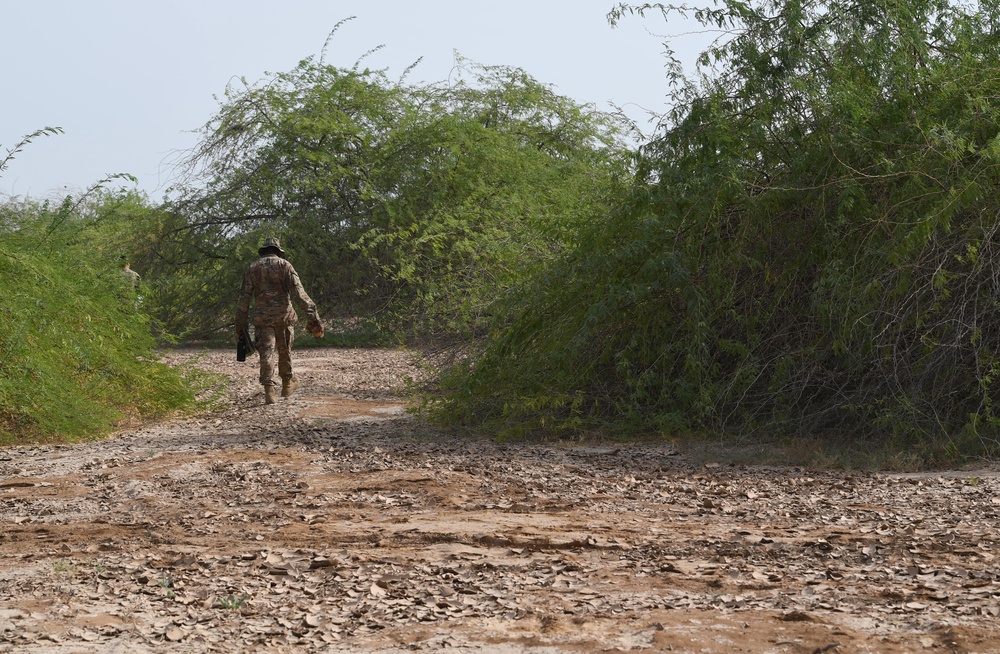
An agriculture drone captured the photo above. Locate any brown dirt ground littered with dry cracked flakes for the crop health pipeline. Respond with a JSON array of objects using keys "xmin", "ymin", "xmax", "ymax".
[{"xmin": 0, "ymin": 350, "xmax": 1000, "ymax": 654}]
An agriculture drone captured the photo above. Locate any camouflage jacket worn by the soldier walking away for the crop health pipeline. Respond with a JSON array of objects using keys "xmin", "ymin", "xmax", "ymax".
[{"xmin": 236, "ymin": 254, "xmax": 319, "ymax": 329}]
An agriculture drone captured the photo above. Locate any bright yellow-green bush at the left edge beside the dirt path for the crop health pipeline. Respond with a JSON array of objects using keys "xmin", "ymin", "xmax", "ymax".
[{"xmin": 0, "ymin": 194, "xmax": 204, "ymax": 442}]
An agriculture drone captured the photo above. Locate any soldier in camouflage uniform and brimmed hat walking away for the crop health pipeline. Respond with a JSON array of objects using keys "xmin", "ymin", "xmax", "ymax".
[{"xmin": 236, "ymin": 237, "xmax": 323, "ymax": 404}]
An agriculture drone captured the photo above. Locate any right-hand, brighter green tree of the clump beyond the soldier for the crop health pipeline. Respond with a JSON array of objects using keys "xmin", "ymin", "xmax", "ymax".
[{"xmin": 361, "ymin": 60, "xmax": 627, "ymax": 333}]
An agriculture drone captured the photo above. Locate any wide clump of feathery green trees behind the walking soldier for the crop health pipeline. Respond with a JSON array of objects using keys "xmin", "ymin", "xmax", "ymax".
[{"xmin": 151, "ymin": 28, "xmax": 627, "ymax": 335}]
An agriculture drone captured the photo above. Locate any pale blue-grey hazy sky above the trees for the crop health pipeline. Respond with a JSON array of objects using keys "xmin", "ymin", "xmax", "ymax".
[{"xmin": 0, "ymin": 0, "xmax": 697, "ymax": 201}]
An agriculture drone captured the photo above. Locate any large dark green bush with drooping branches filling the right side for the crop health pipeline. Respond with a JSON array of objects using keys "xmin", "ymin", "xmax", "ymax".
[{"xmin": 434, "ymin": 0, "xmax": 1000, "ymax": 451}]
